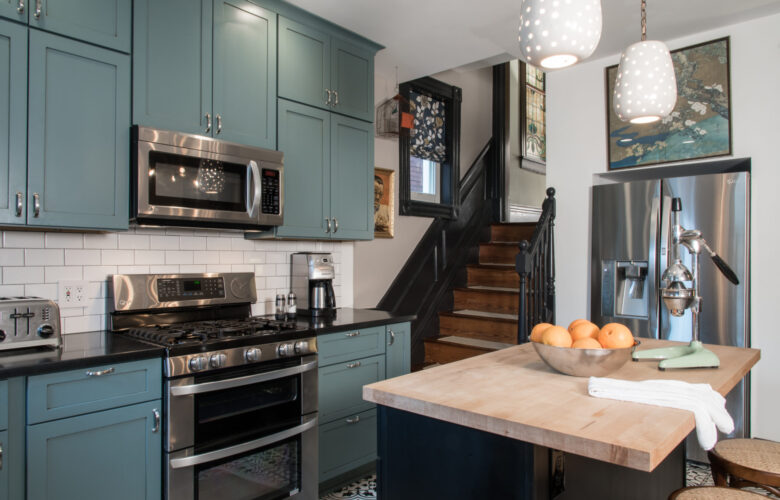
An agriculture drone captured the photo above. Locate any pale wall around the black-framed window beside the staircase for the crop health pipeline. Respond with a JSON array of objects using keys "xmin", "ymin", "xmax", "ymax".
[{"xmin": 354, "ymin": 67, "xmax": 493, "ymax": 307}]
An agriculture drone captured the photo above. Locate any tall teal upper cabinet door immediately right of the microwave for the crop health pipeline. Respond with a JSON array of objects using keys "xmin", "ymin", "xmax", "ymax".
[{"xmin": 277, "ymin": 99, "xmax": 330, "ymax": 238}]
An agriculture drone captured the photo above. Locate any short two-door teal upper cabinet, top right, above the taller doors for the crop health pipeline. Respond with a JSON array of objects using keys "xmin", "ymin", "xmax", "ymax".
[{"xmin": 279, "ymin": 16, "xmax": 375, "ymax": 122}]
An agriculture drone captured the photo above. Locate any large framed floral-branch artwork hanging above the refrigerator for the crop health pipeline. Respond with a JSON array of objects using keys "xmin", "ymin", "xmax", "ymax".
[{"xmin": 605, "ymin": 37, "xmax": 731, "ymax": 170}]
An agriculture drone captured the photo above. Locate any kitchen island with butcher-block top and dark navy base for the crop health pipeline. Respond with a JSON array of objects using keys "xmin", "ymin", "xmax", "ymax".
[{"xmin": 363, "ymin": 339, "xmax": 760, "ymax": 500}]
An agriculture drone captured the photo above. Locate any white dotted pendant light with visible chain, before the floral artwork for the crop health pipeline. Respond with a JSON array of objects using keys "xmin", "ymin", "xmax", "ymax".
[{"xmin": 612, "ymin": 0, "xmax": 677, "ymax": 123}]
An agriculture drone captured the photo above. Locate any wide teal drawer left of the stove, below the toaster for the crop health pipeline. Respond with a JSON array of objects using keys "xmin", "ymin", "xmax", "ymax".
[{"xmin": 27, "ymin": 359, "xmax": 162, "ymax": 424}]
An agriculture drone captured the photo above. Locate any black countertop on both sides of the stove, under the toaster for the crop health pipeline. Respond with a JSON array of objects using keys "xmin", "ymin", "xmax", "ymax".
[{"xmin": 0, "ymin": 308, "xmax": 415, "ymax": 379}]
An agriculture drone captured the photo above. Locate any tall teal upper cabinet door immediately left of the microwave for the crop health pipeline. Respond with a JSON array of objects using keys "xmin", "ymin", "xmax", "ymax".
[{"xmin": 27, "ymin": 30, "xmax": 130, "ymax": 229}]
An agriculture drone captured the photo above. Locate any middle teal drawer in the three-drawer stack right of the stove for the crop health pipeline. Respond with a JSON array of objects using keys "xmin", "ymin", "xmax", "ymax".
[{"xmin": 319, "ymin": 356, "xmax": 385, "ymax": 422}]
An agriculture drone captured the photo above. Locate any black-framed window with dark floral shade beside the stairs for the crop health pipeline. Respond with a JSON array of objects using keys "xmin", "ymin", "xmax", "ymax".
[{"xmin": 398, "ymin": 77, "xmax": 462, "ymax": 218}]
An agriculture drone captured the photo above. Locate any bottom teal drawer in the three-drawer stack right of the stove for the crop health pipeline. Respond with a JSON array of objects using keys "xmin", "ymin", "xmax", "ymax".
[{"xmin": 320, "ymin": 408, "xmax": 377, "ymax": 482}]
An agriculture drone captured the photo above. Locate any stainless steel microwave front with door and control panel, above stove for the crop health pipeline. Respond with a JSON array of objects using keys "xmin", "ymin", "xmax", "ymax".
[{"xmin": 135, "ymin": 141, "xmax": 282, "ymax": 227}]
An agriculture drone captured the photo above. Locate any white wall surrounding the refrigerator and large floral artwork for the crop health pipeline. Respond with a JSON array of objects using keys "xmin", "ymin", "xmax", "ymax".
[{"xmin": 547, "ymin": 15, "xmax": 780, "ymax": 440}]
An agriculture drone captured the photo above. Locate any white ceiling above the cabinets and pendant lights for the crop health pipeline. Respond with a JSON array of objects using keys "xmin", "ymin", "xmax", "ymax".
[{"xmin": 288, "ymin": 0, "xmax": 780, "ymax": 81}]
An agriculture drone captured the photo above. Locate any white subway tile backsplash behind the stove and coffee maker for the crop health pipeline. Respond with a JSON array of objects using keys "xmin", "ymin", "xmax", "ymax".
[{"xmin": 0, "ymin": 228, "xmax": 352, "ymax": 334}]
